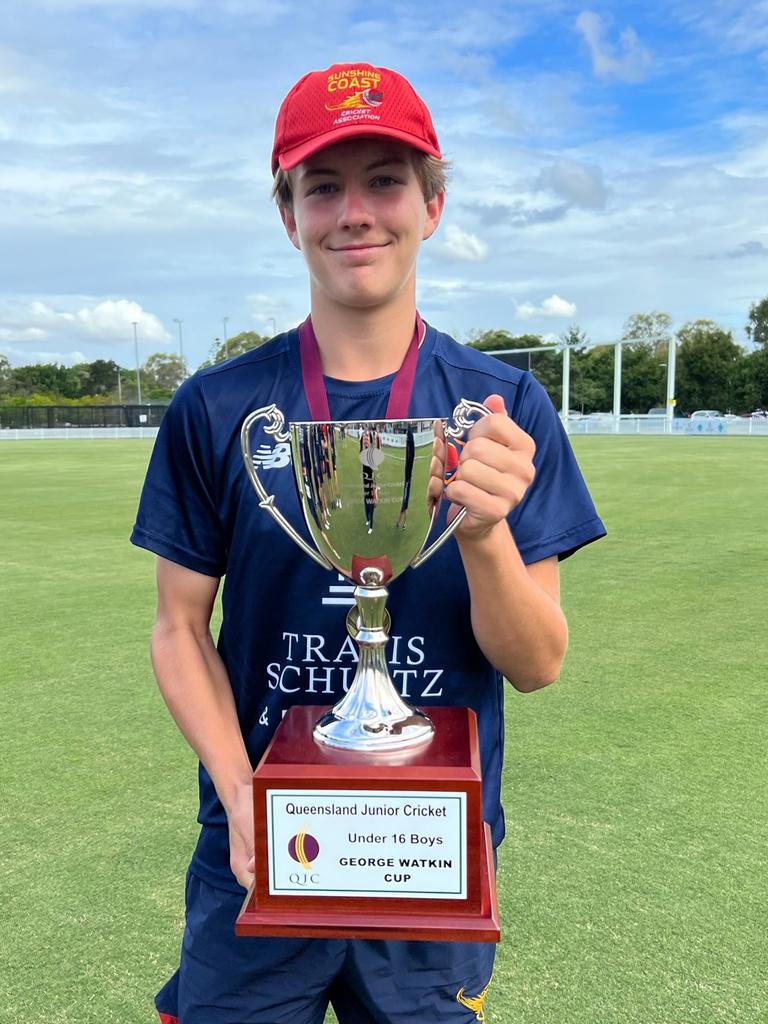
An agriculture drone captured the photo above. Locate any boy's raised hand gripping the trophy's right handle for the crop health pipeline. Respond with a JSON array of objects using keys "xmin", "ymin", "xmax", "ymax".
[{"xmin": 429, "ymin": 394, "xmax": 536, "ymax": 540}]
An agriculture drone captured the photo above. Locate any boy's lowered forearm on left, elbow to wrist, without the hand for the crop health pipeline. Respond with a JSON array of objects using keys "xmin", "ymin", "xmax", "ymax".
[{"xmin": 152, "ymin": 624, "xmax": 253, "ymax": 809}]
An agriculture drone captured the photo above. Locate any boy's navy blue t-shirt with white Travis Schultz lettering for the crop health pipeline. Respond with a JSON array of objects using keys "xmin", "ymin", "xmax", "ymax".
[{"xmin": 131, "ymin": 327, "xmax": 605, "ymax": 890}]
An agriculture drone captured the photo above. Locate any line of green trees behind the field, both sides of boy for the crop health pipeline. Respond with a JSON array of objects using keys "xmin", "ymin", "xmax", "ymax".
[{"xmin": 0, "ymin": 296, "xmax": 768, "ymax": 414}]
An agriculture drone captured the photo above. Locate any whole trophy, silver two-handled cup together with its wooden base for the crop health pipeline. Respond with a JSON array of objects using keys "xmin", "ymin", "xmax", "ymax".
[{"xmin": 236, "ymin": 400, "xmax": 500, "ymax": 942}]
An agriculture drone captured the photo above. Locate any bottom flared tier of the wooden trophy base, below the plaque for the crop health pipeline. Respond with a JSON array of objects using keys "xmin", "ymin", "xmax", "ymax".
[{"xmin": 234, "ymin": 824, "xmax": 501, "ymax": 942}]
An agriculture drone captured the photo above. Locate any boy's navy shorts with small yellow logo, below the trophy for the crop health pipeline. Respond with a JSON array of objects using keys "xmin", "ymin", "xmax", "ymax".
[{"xmin": 156, "ymin": 872, "xmax": 496, "ymax": 1024}]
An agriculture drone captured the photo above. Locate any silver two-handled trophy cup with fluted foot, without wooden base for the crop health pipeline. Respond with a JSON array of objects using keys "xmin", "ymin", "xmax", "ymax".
[{"xmin": 241, "ymin": 399, "xmax": 489, "ymax": 752}]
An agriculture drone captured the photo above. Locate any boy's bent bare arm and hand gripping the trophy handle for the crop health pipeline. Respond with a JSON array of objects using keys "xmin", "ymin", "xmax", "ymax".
[{"xmin": 436, "ymin": 395, "xmax": 568, "ymax": 690}]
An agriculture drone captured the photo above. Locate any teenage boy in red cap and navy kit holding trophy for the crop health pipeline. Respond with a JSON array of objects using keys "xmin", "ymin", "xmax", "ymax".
[{"xmin": 132, "ymin": 63, "xmax": 604, "ymax": 1024}]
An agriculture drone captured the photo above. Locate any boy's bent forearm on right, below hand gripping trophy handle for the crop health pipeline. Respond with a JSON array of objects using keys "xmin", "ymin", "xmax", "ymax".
[{"xmin": 457, "ymin": 521, "xmax": 568, "ymax": 691}]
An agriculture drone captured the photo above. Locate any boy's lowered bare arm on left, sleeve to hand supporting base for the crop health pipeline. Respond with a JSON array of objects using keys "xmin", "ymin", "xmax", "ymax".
[{"xmin": 152, "ymin": 558, "xmax": 254, "ymax": 888}]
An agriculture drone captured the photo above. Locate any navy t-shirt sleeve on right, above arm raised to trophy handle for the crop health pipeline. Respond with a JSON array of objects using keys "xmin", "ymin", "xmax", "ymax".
[{"xmin": 509, "ymin": 375, "xmax": 605, "ymax": 565}]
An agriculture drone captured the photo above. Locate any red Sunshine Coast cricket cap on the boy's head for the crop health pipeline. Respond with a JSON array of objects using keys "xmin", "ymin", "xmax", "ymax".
[{"xmin": 272, "ymin": 63, "xmax": 442, "ymax": 174}]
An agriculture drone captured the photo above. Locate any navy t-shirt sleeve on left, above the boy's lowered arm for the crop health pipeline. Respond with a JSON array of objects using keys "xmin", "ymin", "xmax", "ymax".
[{"xmin": 131, "ymin": 377, "xmax": 226, "ymax": 577}]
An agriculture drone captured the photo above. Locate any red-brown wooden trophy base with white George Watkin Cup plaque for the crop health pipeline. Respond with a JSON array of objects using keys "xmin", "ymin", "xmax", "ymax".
[{"xmin": 236, "ymin": 707, "xmax": 501, "ymax": 942}]
